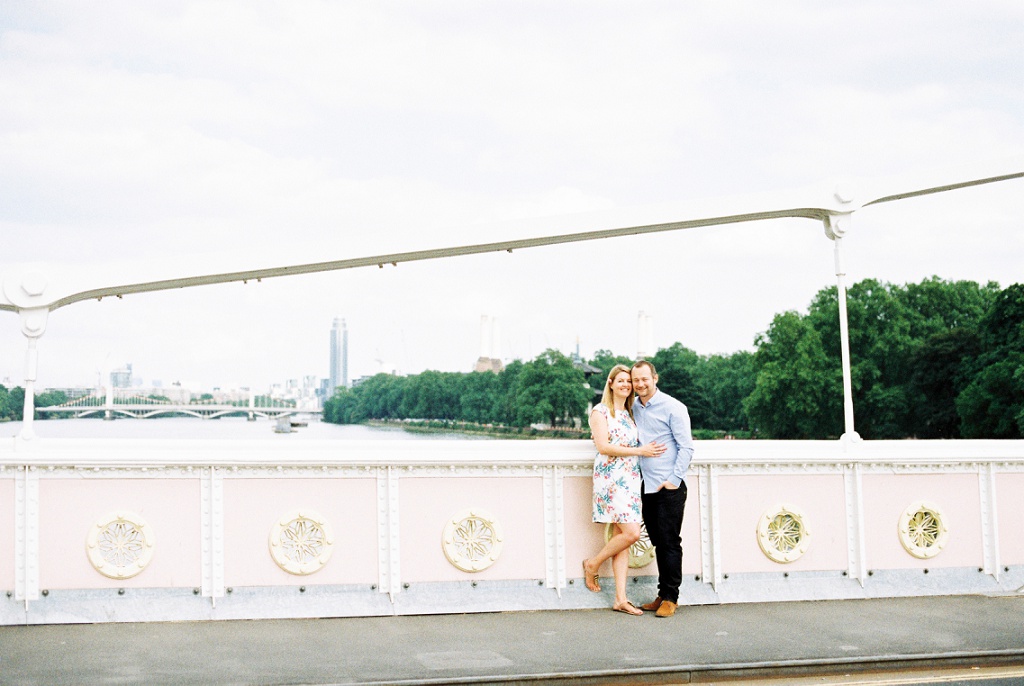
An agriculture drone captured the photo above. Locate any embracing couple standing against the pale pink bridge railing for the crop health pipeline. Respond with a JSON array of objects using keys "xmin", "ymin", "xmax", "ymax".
[{"xmin": 583, "ymin": 359, "xmax": 693, "ymax": 617}]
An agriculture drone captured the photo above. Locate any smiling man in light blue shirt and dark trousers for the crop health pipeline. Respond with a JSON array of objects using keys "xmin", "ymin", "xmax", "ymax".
[{"xmin": 630, "ymin": 359, "xmax": 693, "ymax": 617}]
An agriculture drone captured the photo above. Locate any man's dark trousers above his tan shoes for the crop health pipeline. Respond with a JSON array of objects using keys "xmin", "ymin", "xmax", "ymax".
[{"xmin": 641, "ymin": 483, "xmax": 686, "ymax": 604}]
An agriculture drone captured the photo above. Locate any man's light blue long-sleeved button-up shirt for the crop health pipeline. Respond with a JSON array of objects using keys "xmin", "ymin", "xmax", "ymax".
[{"xmin": 633, "ymin": 391, "xmax": 693, "ymax": 494}]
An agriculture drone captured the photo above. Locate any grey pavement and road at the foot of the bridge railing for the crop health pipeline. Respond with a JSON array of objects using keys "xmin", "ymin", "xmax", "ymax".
[{"xmin": 0, "ymin": 595, "xmax": 1024, "ymax": 686}]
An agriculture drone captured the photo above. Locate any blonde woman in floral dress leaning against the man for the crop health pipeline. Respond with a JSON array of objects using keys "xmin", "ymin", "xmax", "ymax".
[{"xmin": 583, "ymin": 365, "xmax": 665, "ymax": 615}]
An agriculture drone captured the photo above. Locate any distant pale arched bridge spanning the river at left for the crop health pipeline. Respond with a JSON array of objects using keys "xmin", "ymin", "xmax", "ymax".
[{"xmin": 36, "ymin": 388, "xmax": 323, "ymax": 419}]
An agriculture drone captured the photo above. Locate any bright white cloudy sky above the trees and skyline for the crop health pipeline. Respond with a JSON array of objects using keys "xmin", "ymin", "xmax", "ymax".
[{"xmin": 0, "ymin": 0, "xmax": 1024, "ymax": 389}]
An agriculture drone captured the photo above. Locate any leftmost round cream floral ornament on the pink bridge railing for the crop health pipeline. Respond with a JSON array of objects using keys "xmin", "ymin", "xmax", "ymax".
[{"xmin": 85, "ymin": 511, "xmax": 157, "ymax": 578}]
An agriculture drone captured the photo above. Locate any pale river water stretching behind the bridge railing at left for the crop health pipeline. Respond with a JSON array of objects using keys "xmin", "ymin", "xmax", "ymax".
[{"xmin": 0, "ymin": 417, "xmax": 479, "ymax": 441}]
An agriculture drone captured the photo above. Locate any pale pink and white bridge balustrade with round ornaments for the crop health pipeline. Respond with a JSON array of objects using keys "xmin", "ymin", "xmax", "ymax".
[{"xmin": 0, "ymin": 439, "xmax": 1024, "ymax": 625}]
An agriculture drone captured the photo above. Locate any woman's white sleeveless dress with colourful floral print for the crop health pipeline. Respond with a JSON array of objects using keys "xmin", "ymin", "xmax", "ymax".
[{"xmin": 591, "ymin": 404, "xmax": 643, "ymax": 523}]
